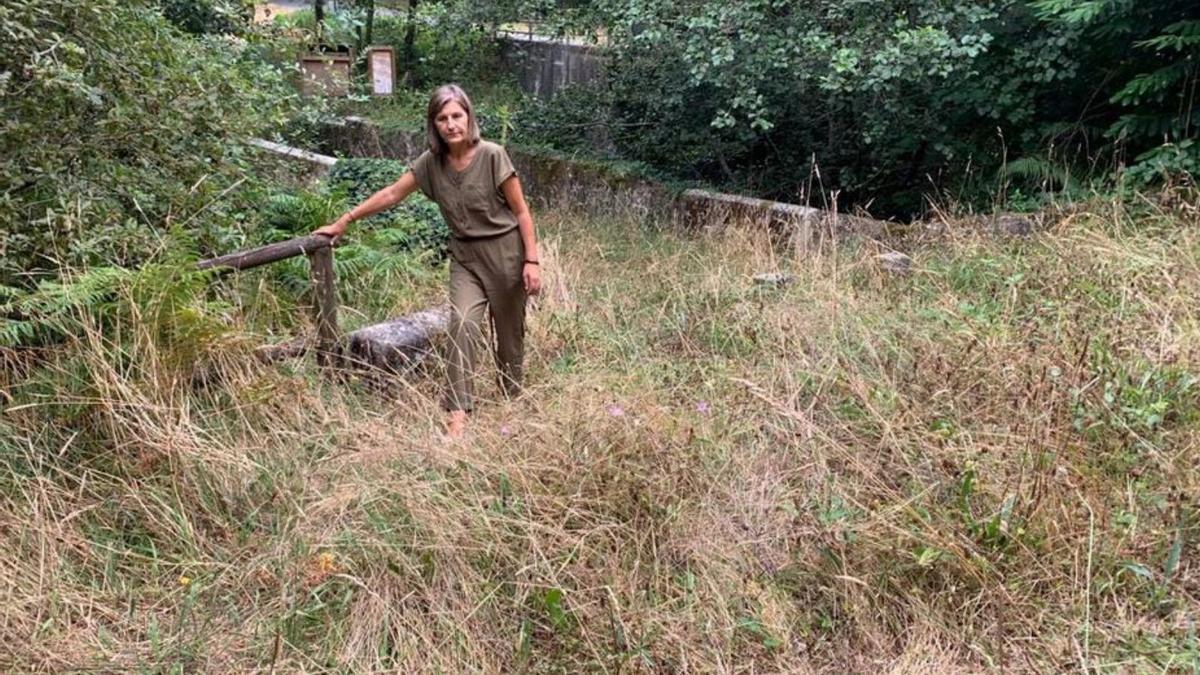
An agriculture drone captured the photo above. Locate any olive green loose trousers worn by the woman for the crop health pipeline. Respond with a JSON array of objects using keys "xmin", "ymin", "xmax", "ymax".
[{"xmin": 443, "ymin": 229, "xmax": 526, "ymax": 412}]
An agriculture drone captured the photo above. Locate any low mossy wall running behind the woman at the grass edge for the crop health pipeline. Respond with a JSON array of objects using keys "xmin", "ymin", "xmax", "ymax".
[{"xmin": 323, "ymin": 118, "xmax": 886, "ymax": 245}]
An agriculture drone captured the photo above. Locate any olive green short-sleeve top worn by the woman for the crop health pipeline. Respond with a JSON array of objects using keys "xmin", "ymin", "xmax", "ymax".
[{"xmin": 409, "ymin": 141, "xmax": 517, "ymax": 239}]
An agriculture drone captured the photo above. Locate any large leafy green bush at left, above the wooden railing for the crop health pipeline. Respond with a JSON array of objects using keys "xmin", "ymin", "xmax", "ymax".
[{"xmin": 0, "ymin": 0, "xmax": 301, "ymax": 286}]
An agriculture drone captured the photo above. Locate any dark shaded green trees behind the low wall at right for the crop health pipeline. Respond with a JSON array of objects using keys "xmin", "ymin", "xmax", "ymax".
[{"xmin": 462, "ymin": 0, "xmax": 1200, "ymax": 216}]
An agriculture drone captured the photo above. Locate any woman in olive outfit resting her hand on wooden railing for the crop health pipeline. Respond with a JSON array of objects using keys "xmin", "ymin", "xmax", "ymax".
[{"xmin": 314, "ymin": 84, "xmax": 541, "ymax": 437}]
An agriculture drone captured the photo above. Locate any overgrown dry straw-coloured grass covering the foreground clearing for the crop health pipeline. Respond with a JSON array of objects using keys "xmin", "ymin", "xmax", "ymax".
[{"xmin": 0, "ymin": 196, "xmax": 1200, "ymax": 673}]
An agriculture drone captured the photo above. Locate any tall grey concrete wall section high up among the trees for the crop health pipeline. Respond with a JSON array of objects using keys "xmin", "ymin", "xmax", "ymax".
[{"xmin": 497, "ymin": 32, "xmax": 605, "ymax": 98}]
